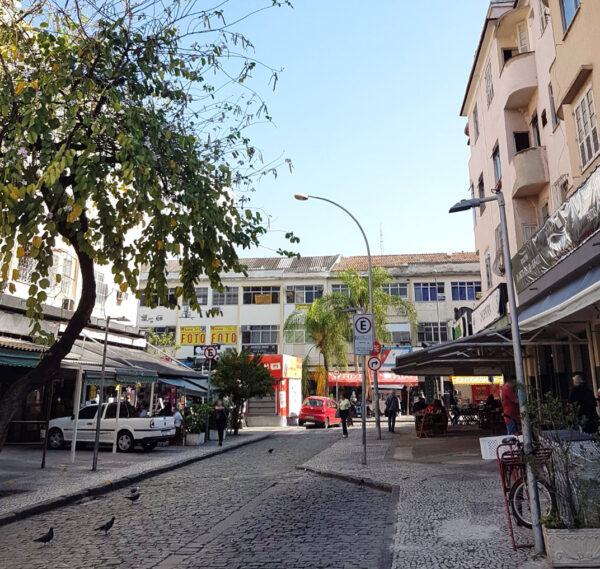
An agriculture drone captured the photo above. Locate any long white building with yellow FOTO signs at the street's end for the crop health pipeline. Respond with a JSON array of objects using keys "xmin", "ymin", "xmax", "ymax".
[{"xmin": 137, "ymin": 253, "xmax": 481, "ymax": 363}]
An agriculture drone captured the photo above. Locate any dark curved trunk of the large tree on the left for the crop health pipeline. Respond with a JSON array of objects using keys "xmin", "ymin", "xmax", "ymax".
[{"xmin": 0, "ymin": 243, "xmax": 96, "ymax": 451}]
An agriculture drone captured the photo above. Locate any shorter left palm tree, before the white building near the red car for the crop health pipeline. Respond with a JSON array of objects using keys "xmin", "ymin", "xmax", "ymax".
[{"xmin": 284, "ymin": 293, "xmax": 350, "ymax": 395}]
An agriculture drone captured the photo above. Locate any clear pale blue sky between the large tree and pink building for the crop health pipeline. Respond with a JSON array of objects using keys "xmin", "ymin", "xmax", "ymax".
[{"xmin": 232, "ymin": 0, "xmax": 489, "ymax": 257}]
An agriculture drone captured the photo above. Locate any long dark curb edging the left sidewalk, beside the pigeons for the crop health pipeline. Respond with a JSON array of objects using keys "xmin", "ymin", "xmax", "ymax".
[{"xmin": 0, "ymin": 433, "xmax": 271, "ymax": 527}]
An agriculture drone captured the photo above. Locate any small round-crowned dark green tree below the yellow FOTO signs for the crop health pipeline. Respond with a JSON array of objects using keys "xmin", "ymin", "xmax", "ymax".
[{"xmin": 211, "ymin": 350, "xmax": 273, "ymax": 435}]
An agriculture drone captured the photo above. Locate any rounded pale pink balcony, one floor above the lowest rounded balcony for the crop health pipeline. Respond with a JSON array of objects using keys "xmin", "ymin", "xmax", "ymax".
[{"xmin": 500, "ymin": 51, "xmax": 538, "ymax": 110}]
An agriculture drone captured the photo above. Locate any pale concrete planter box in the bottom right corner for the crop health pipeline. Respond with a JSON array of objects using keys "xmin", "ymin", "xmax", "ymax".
[{"xmin": 543, "ymin": 528, "xmax": 600, "ymax": 567}]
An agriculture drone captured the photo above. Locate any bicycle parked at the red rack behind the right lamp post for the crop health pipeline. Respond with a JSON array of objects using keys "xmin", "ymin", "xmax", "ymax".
[{"xmin": 496, "ymin": 437, "xmax": 555, "ymax": 549}]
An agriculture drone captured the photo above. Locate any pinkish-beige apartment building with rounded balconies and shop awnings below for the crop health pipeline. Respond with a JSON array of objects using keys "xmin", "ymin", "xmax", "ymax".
[{"xmin": 460, "ymin": 0, "xmax": 600, "ymax": 397}]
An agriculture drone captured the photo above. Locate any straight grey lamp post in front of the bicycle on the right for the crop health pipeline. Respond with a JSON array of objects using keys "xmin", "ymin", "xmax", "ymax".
[{"xmin": 450, "ymin": 189, "xmax": 544, "ymax": 553}]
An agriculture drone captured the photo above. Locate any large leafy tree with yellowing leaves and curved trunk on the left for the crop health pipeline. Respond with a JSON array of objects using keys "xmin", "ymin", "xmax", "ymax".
[{"xmin": 0, "ymin": 0, "xmax": 295, "ymax": 448}]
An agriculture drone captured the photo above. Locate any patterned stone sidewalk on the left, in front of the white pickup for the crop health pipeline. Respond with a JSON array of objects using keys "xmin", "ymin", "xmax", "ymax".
[{"xmin": 0, "ymin": 429, "xmax": 271, "ymax": 526}]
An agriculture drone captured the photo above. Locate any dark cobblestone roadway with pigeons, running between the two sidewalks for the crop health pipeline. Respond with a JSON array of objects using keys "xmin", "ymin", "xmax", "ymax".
[{"xmin": 0, "ymin": 429, "xmax": 391, "ymax": 569}]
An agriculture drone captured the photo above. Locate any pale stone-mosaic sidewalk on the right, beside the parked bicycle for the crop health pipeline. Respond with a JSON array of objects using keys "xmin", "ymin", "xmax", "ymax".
[{"xmin": 300, "ymin": 420, "xmax": 549, "ymax": 569}]
